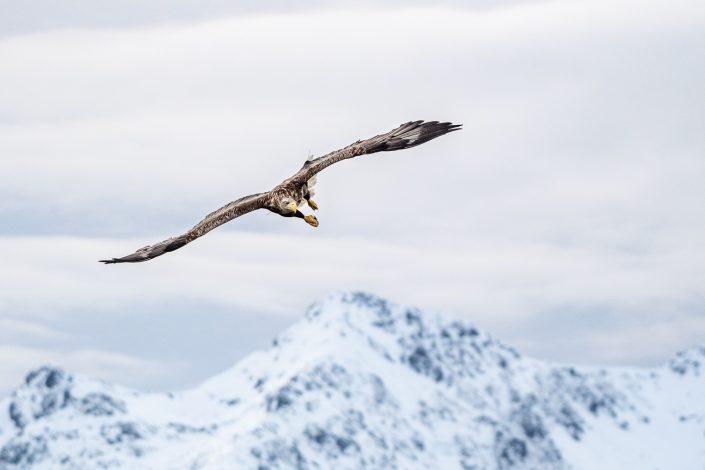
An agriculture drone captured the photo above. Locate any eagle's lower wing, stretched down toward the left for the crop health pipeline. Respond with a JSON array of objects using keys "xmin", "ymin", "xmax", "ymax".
[{"xmin": 100, "ymin": 193, "xmax": 269, "ymax": 264}]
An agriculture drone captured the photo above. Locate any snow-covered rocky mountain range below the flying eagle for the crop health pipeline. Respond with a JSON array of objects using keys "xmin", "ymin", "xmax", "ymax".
[{"xmin": 0, "ymin": 293, "xmax": 705, "ymax": 470}]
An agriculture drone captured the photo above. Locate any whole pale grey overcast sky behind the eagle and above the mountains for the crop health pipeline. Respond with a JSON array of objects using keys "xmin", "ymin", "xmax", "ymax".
[{"xmin": 0, "ymin": 0, "xmax": 705, "ymax": 391}]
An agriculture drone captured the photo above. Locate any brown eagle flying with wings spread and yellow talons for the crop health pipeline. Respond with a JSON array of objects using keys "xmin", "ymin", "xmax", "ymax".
[{"xmin": 100, "ymin": 121, "xmax": 462, "ymax": 264}]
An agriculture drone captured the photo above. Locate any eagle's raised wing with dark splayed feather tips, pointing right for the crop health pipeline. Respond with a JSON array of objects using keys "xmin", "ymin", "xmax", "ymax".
[{"xmin": 288, "ymin": 121, "xmax": 462, "ymax": 184}]
